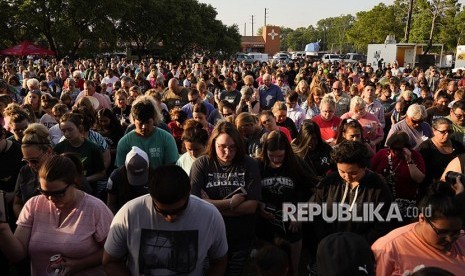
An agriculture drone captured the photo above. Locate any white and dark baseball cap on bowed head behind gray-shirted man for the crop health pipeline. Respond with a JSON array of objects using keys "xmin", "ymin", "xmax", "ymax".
[{"xmin": 124, "ymin": 146, "xmax": 149, "ymax": 186}]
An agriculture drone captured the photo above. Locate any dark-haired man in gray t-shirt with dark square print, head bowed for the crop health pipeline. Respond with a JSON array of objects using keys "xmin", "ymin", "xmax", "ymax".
[{"xmin": 103, "ymin": 165, "xmax": 228, "ymax": 275}]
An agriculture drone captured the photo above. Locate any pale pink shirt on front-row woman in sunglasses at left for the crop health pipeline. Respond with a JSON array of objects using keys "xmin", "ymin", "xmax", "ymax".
[{"xmin": 17, "ymin": 194, "xmax": 113, "ymax": 275}]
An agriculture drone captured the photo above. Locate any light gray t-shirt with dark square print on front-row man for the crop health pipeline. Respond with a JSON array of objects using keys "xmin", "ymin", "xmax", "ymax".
[{"xmin": 105, "ymin": 195, "xmax": 228, "ymax": 275}]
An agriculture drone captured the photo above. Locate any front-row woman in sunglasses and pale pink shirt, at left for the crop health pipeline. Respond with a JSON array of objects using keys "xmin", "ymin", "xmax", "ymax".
[{"xmin": 0, "ymin": 156, "xmax": 113, "ymax": 275}]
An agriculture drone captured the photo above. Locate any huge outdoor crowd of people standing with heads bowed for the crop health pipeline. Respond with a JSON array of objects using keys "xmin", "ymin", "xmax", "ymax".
[{"xmin": 0, "ymin": 57, "xmax": 465, "ymax": 275}]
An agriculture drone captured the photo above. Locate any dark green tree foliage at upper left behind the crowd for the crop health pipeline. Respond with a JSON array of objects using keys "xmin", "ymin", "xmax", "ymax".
[{"xmin": 0, "ymin": 0, "xmax": 240, "ymax": 58}]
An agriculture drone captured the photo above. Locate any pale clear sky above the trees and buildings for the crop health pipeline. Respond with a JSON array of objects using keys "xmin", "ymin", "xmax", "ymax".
[{"xmin": 199, "ymin": 0, "xmax": 465, "ymax": 35}]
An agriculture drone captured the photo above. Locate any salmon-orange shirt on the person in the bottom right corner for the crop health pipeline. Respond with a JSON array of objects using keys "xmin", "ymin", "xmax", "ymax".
[{"xmin": 371, "ymin": 223, "xmax": 465, "ymax": 276}]
